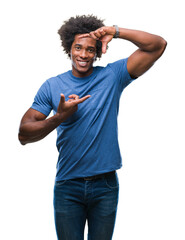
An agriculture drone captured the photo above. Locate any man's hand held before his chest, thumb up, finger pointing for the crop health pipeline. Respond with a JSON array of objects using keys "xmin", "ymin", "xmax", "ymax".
[{"xmin": 56, "ymin": 94, "xmax": 90, "ymax": 122}]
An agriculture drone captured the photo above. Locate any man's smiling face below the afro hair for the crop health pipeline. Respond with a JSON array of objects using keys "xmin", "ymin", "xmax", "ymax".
[{"xmin": 71, "ymin": 34, "xmax": 96, "ymax": 77}]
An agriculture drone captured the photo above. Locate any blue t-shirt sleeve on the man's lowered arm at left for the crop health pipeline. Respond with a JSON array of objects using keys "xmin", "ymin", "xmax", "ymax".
[{"xmin": 31, "ymin": 81, "xmax": 53, "ymax": 116}]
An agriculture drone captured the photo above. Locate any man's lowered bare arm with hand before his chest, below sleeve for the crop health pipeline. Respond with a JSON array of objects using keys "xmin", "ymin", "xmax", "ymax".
[{"xmin": 18, "ymin": 94, "xmax": 90, "ymax": 145}]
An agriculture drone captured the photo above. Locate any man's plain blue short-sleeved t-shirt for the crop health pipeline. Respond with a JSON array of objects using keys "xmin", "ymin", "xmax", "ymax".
[{"xmin": 31, "ymin": 59, "xmax": 136, "ymax": 181}]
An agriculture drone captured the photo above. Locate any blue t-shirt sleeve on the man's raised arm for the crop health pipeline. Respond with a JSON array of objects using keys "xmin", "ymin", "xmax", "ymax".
[{"xmin": 109, "ymin": 58, "xmax": 136, "ymax": 90}]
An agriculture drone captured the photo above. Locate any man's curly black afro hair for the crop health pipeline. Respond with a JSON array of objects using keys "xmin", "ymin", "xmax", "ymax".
[{"xmin": 58, "ymin": 15, "xmax": 105, "ymax": 58}]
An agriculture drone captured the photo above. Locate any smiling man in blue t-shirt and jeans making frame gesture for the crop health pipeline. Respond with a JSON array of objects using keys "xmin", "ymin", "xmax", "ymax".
[{"xmin": 19, "ymin": 16, "xmax": 167, "ymax": 240}]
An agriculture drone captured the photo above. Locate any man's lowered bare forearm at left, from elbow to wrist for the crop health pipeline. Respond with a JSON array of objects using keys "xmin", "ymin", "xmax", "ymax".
[{"xmin": 19, "ymin": 114, "xmax": 62, "ymax": 145}]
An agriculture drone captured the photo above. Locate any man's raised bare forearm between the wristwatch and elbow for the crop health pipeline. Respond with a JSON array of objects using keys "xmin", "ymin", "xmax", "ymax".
[{"xmin": 119, "ymin": 28, "xmax": 165, "ymax": 52}]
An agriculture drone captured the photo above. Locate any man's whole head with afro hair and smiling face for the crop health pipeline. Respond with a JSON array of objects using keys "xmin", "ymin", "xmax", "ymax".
[{"xmin": 58, "ymin": 15, "xmax": 104, "ymax": 75}]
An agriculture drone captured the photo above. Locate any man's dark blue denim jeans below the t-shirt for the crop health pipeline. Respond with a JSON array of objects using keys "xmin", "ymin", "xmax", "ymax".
[{"xmin": 54, "ymin": 172, "xmax": 119, "ymax": 240}]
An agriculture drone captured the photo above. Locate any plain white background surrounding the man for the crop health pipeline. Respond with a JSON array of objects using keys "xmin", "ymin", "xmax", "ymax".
[{"xmin": 0, "ymin": 0, "xmax": 185, "ymax": 240}]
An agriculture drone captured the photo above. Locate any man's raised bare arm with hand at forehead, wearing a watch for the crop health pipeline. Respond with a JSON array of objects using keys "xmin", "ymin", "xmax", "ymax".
[{"xmin": 82, "ymin": 27, "xmax": 167, "ymax": 78}]
